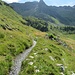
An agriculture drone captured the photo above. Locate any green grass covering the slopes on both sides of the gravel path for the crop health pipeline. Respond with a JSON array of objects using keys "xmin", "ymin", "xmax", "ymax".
[{"xmin": 0, "ymin": 1, "xmax": 75, "ymax": 75}]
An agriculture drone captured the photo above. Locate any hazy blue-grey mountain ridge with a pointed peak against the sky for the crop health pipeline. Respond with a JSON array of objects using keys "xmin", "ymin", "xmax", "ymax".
[{"xmin": 10, "ymin": 0, "xmax": 75, "ymax": 25}]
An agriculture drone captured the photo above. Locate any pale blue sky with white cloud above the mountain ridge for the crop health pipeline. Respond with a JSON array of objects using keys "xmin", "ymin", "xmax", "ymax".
[{"xmin": 3, "ymin": 0, "xmax": 75, "ymax": 6}]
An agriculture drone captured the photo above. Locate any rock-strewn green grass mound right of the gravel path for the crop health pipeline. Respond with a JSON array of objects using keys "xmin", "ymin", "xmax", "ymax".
[{"xmin": 19, "ymin": 38, "xmax": 75, "ymax": 75}]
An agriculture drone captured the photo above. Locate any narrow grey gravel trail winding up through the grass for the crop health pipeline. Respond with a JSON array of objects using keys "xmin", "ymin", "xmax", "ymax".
[{"xmin": 9, "ymin": 41, "xmax": 36, "ymax": 75}]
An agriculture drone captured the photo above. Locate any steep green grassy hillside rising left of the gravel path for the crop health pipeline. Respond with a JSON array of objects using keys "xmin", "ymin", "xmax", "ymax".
[{"xmin": 0, "ymin": 0, "xmax": 45, "ymax": 75}]
